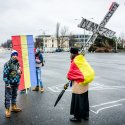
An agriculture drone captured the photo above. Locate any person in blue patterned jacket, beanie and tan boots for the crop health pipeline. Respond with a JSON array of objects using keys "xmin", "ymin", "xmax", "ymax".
[{"xmin": 3, "ymin": 50, "xmax": 22, "ymax": 118}]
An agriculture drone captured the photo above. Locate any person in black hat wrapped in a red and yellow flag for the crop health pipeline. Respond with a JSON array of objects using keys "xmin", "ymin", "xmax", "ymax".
[{"xmin": 67, "ymin": 48, "xmax": 95, "ymax": 122}]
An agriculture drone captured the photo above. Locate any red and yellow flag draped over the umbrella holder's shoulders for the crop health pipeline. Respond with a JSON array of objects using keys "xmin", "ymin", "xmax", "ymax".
[{"xmin": 67, "ymin": 55, "xmax": 95, "ymax": 85}]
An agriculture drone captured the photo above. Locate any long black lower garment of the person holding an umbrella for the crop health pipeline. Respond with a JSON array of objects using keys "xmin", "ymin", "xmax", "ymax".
[{"xmin": 70, "ymin": 91, "xmax": 89, "ymax": 118}]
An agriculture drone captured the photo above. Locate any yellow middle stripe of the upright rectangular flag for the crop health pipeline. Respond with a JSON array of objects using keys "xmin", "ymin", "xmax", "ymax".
[{"xmin": 21, "ymin": 35, "xmax": 31, "ymax": 88}]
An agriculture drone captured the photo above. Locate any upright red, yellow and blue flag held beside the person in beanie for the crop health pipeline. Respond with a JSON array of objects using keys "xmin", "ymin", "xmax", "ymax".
[{"xmin": 12, "ymin": 35, "xmax": 37, "ymax": 90}]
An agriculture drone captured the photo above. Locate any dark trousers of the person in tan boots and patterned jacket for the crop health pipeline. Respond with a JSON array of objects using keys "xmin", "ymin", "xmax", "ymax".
[{"xmin": 5, "ymin": 84, "xmax": 19, "ymax": 108}]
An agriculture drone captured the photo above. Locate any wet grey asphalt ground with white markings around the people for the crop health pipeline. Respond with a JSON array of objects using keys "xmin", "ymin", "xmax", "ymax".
[{"xmin": 0, "ymin": 52, "xmax": 125, "ymax": 125}]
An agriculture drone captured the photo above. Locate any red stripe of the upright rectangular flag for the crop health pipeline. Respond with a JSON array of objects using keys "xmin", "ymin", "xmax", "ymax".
[{"xmin": 12, "ymin": 36, "xmax": 25, "ymax": 90}]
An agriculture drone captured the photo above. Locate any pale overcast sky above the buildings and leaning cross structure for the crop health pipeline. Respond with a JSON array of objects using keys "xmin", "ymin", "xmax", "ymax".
[{"xmin": 0, "ymin": 0, "xmax": 125, "ymax": 43}]
